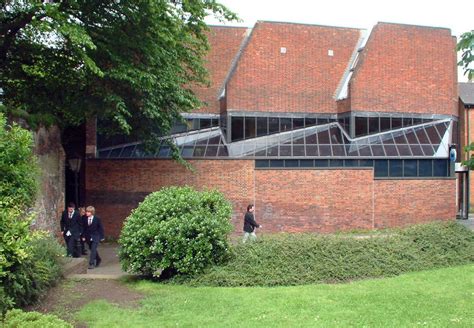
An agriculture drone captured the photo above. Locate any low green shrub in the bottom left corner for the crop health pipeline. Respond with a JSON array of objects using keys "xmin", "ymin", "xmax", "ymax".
[{"xmin": 3, "ymin": 309, "xmax": 72, "ymax": 328}]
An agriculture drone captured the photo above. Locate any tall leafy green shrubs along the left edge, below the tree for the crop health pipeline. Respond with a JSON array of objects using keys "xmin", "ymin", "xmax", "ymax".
[{"xmin": 0, "ymin": 113, "xmax": 61, "ymax": 314}]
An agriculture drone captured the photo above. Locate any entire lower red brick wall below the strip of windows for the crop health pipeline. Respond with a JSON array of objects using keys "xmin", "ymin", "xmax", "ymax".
[{"xmin": 86, "ymin": 160, "xmax": 456, "ymax": 237}]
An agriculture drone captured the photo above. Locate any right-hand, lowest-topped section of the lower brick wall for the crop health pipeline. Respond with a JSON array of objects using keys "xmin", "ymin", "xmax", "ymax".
[{"xmin": 374, "ymin": 179, "xmax": 456, "ymax": 228}]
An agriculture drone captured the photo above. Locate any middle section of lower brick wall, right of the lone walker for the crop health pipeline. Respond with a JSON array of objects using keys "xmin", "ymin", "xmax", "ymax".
[{"xmin": 255, "ymin": 169, "xmax": 373, "ymax": 232}]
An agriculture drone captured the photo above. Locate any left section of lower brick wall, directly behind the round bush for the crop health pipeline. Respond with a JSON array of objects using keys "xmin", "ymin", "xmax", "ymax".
[{"xmin": 86, "ymin": 160, "xmax": 255, "ymax": 237}]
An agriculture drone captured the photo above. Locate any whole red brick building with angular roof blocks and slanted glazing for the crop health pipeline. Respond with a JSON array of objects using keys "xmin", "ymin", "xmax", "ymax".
[{"xmin": 86, "ymin": 22, "xmax": 459, "ymax": 236}]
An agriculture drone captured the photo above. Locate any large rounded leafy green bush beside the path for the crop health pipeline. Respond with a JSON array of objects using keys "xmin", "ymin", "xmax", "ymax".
[{"xmin": 119, "ymin": 187, "xmax": 232, "ymax": 277}]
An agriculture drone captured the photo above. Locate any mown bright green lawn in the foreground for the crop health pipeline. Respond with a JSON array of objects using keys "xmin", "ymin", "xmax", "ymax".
[{"xmin": 77, "ymin": 265, "xmax": 474, "ymax": 328}]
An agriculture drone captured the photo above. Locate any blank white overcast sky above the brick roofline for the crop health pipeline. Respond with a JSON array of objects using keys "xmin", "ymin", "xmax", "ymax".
[{"xmin": 207, "ymin": 0, "xmax": 474, "ymax": 81}]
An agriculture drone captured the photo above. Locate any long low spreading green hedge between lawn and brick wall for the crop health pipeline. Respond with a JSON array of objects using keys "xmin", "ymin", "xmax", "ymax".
[{"xmin": 185, "ymin": 222, "xmax": 474, "ymax": 286}]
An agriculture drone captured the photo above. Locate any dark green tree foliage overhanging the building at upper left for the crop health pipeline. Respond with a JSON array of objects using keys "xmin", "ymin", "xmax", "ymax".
[{"xmin": 0, "ymin": 0, "xmax": 236, "ymax": 134}]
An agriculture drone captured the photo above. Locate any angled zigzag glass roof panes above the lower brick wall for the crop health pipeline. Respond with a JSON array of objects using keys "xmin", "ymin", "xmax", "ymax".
[{"xmin": 98, "ymin": 118, "xmax": 453, "ymax": 159}]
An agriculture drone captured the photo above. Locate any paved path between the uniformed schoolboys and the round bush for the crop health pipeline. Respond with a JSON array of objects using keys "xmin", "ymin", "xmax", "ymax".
[{"xmin": 66, "ymin": 243, "xmax": 130, "ymax": 279}]
